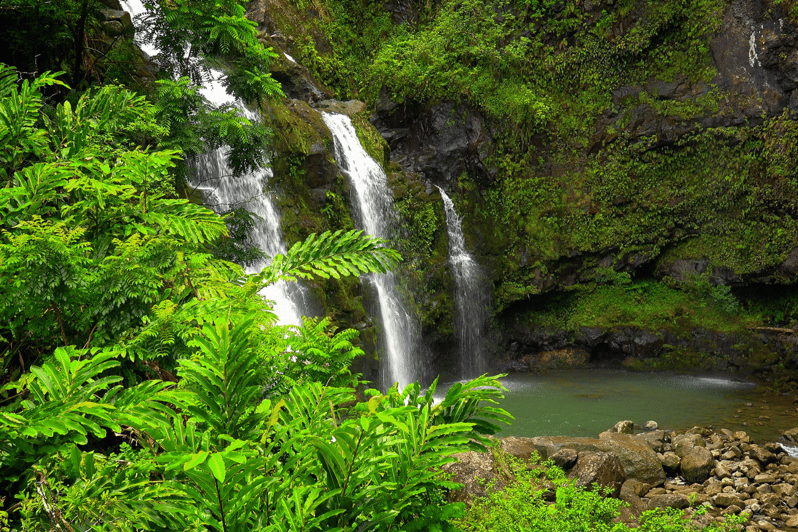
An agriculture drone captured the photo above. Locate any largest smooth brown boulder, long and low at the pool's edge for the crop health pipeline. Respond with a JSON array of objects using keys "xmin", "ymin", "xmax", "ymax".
[{"xmin": 531, "ymin": 433, "xmax": 665, "ymax": 486}]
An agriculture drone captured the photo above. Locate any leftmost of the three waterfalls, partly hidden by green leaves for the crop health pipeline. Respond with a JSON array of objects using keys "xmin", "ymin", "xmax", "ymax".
[{"xmin": 123, "ymin": 0, "xmax": 308, "ymax": 325}]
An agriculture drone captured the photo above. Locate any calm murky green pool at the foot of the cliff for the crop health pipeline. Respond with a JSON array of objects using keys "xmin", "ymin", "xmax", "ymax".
[{"xmin": 444, "ymin": 369, "xmax": 798, "ymax": 441}]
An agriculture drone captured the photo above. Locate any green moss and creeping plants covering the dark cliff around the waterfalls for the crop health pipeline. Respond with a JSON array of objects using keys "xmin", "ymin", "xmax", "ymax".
[{"xmin": 260, "ymin": 0, "xmax": 798, "ymax": 370}]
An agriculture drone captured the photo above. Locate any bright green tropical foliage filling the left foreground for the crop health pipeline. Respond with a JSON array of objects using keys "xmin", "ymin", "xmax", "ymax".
[{"xmin": 0, "ymin": 63, "xmax": 508, "ymax": 531}]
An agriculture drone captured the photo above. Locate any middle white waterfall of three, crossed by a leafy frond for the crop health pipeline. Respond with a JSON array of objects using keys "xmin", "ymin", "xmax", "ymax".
[{"xmin": 321, "ymin": 113, "xmax": 420, "ymax": 388}]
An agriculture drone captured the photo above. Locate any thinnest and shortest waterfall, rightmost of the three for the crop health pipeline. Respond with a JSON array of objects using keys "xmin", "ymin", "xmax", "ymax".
[{"xmin": 438, "ymin": 187, "xmax": 490, "ymax": 379}]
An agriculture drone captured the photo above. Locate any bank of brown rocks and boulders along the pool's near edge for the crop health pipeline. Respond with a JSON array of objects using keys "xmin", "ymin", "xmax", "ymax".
[{"xmin": 445, "ymin": 421, "xmax": 798, "ymax": 532}]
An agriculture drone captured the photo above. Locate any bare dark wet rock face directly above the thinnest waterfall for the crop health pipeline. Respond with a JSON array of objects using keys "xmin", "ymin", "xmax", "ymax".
[{"xmin": 372, "ymin": 93, "xmax": 491, "ymax": 185}]
